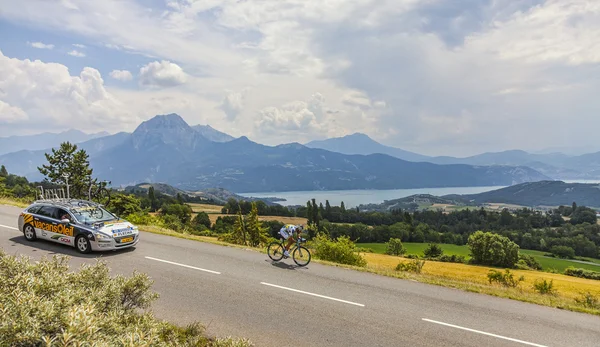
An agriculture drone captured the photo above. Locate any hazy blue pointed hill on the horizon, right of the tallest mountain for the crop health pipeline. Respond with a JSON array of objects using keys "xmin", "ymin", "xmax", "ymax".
[{"xmin": 306, "ymin": 133, "xmax": 430, "ymax": 162}]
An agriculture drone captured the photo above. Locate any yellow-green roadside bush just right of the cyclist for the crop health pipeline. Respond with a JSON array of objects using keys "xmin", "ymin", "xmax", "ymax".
[{"xmin": 310, "ymin": 233, "xmax": 367, "ymax": 266}]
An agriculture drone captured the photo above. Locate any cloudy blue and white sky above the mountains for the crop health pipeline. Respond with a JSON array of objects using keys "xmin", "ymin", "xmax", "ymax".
[{"xmin": 0, "ymin": 0, "xmax": 600, "ymax": 156}]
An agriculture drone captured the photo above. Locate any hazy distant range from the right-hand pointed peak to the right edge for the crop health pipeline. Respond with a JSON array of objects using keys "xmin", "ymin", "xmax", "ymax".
[{"xmin": 306, "ymin": 133, "xmax": 600, "ymax": 180}]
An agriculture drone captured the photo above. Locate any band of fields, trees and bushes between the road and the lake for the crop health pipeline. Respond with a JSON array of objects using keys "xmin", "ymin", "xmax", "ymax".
[{"xmin": 0, "ymin": 141, "xmax": 600, "ymax": 315}]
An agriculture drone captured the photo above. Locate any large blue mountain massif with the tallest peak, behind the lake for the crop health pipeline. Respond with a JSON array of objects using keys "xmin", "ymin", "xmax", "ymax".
[{"xmin": 0, "ymin": 114, "xmax": 549, "ymax": 193}]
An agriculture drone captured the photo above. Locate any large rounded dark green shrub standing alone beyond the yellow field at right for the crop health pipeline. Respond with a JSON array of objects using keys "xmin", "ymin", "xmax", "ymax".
[{"xmin": 468, "ymin": 231, "xmax": 519, "ymax": 268}]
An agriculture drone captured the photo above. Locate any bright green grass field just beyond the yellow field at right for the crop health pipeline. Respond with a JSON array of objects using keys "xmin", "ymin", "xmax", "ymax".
[{"xmin": 356, "ymin": 242, "xmax": 600, "ymax": 273}]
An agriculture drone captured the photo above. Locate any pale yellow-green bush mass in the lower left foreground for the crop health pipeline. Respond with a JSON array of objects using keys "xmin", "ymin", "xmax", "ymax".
[{"xmin": 0, "ymin": 251, "xmax": 250, "ymax": 346}]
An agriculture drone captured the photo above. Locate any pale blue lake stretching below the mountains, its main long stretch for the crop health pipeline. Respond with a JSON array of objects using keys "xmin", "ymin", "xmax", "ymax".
[{"xmin": 238, "ymin": 186, "xmax": 505, "ymax": 208}]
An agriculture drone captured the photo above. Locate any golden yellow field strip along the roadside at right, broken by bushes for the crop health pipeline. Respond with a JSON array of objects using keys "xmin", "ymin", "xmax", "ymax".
[{"xmin": 361, "ymin": 253, "xmax": 600, "ymax": 299}]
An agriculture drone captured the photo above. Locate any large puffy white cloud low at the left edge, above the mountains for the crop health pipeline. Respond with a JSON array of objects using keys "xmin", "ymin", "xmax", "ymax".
[{"xmin": 0, "ymin": 52, "xmax": 139, "ymax": 132}]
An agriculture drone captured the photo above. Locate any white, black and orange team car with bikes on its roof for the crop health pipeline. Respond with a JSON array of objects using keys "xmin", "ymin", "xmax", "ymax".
[{"xmin": 18, "ymin": 199, "xmax": 140, "ymax": 253}]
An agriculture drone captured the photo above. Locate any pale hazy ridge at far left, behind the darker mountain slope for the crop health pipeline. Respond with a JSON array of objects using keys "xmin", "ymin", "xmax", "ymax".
[{"xmin": 0, "ymin": 130, "xmax": 109, "ymax": 155}]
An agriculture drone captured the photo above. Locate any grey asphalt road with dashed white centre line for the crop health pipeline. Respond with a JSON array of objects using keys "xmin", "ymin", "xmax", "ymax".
[{"xmin": 0, "ymin": 206, "xmax": 600, "ymax": 347}]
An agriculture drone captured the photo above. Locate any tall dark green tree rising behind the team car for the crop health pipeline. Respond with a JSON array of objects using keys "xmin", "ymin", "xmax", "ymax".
[{"xmin": 37, "ymin": 142, "xmax": 97, "ymax": 197}]
